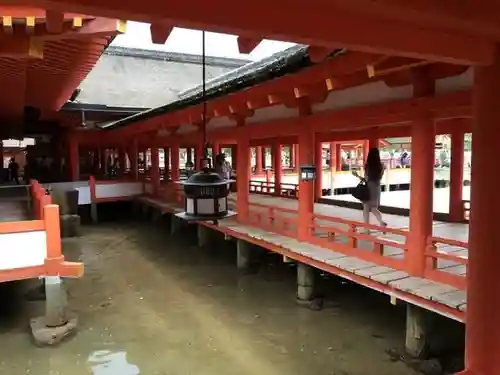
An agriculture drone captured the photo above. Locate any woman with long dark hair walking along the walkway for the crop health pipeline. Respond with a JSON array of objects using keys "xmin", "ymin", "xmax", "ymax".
[{"xmin": 352, "ymin": 148, "xmax": 387, "ymax": 232}]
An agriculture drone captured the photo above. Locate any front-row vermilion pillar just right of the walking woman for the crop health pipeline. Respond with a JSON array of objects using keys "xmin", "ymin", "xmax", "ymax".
[{"xmin": 405, "ymin": 77, "xmax": 436, "ymax": 276}]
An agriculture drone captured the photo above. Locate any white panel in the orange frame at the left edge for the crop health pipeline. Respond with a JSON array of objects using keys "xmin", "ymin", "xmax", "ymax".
[{"xmin": 0, "ymin": 231, "xmax": 47, "ymax": 270}]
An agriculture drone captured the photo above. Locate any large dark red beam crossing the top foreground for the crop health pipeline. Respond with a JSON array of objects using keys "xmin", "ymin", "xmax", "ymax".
[{"xmin": 15, "ymin": 0, "xmax": 500, "ymax": 65}]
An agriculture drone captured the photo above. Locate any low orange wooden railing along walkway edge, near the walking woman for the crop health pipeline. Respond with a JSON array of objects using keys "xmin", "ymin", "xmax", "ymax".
[{"xmin": 243, "ymin": 203, "xmax": 468, "ymax": 289}]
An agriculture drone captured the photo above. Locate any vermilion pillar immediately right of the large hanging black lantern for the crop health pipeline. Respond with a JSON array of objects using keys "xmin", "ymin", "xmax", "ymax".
[{"xmin": 235, "ymin": 134, "xmax": 250, "ymax": 222}]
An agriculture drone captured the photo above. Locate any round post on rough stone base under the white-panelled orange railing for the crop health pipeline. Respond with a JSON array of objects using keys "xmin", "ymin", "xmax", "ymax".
[{"xmin": 30, "ymin": 276, "xmax": 77, "ymax": 346}]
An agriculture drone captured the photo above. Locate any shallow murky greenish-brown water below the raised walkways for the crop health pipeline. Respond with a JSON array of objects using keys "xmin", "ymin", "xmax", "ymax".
[{"xmin": 0, "ymin": 219, "xmax": 415, "ymax": 375}]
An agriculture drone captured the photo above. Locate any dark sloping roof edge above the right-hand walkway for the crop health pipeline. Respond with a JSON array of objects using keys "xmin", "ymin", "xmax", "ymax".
[{"xmin": 102, "ymin": 45, "xmax": 345, "ymax": 131}]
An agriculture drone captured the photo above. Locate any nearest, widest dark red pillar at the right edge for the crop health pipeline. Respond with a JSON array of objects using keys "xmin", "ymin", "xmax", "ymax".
[{"xmin": 465, "ymin": 51, "xmax": 500, "ymax": 375}]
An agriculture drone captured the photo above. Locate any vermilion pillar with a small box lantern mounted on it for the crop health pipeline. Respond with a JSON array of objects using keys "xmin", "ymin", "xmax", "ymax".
[{"xmin": 297, "ymin": 102, "xmax": 314, "ymax": 240}]
